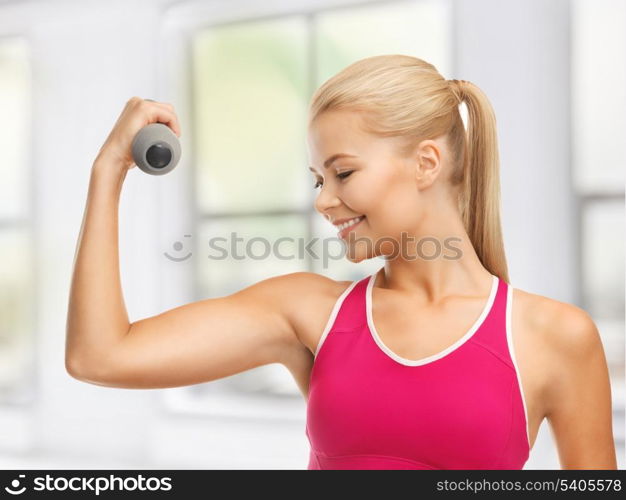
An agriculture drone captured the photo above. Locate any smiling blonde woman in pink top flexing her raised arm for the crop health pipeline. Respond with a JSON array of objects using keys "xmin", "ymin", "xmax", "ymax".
[{"xmin": 66, "ymin": 55, "xmax": 616, "ymax": 469}]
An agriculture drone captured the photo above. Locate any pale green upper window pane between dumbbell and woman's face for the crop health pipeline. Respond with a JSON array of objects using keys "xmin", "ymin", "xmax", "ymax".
[{"xmin": 193, "ymin": 16, "xmax": 310, "ymax": 211}]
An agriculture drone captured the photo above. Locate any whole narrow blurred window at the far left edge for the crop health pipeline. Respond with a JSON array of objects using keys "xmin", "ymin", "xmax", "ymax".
[{"xmin": 0, "ymin": 38, "xmax": 35, "ymax": 404}]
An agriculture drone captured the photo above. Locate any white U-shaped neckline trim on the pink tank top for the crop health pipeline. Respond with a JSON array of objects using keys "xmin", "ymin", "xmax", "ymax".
[{"xmin": 365, "ymin": 273, "xmax": 498, "ymax": 366}]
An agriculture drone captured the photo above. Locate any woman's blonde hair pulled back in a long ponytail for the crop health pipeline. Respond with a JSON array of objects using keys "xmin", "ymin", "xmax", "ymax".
[{"xmin": 308, "ymin": 54, "xmax": 509, "ymax": 282}]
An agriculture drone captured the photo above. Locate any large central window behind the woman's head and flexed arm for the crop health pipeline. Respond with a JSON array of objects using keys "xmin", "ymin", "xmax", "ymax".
[{"xmin": 170, "ymin": 2, "xmax": 451, "ymax": 399}]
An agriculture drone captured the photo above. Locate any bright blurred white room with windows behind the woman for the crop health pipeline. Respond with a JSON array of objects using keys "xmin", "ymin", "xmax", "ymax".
[{"xmin": 0, "ymin": 0, "xmax": 626, "ymax": 469}]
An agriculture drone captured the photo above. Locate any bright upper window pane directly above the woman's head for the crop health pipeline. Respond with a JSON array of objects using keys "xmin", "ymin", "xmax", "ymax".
[{"xmin": 315, "ymin": 2, "xmax": 452, "ymax": 85}]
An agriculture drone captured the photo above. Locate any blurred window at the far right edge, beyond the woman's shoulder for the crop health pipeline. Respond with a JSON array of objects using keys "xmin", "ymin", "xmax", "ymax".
[{"xmin": 571, "ymin": 0, "xmax": 626, "ymax": 456}]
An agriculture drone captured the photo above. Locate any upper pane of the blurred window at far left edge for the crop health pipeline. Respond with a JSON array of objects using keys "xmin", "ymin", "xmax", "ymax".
[{"xmin": 0, "ymin": 38, "xmax": 30, "ymax": 219}]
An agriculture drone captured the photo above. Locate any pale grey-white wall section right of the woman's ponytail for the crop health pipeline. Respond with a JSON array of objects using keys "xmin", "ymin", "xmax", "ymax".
[{"xmin": 448, "ymin": 0, "xmax": 577, "ymax": 302}]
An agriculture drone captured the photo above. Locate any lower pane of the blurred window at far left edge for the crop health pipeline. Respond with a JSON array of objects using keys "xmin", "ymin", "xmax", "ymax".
[{"xmin": 0, "ymin": 229, "xmax": 35, "ymax": 402}]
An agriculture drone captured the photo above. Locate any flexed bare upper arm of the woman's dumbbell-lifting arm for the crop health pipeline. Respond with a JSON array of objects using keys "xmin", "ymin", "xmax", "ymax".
[{"xmin": 72, "ymin": 273, "xmax": 311, "ymax": 388}]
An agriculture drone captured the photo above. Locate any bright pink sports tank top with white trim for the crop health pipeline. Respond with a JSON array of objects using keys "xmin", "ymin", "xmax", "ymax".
[{"xmin": 306, "ymin": 273, "xmax": 530, "ymax": 469}]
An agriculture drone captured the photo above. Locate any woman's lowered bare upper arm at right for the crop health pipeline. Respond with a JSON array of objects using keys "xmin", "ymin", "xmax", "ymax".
[{"xmin": 546, "ymin": 303, "xmax": 617, "ymax": 469}]
